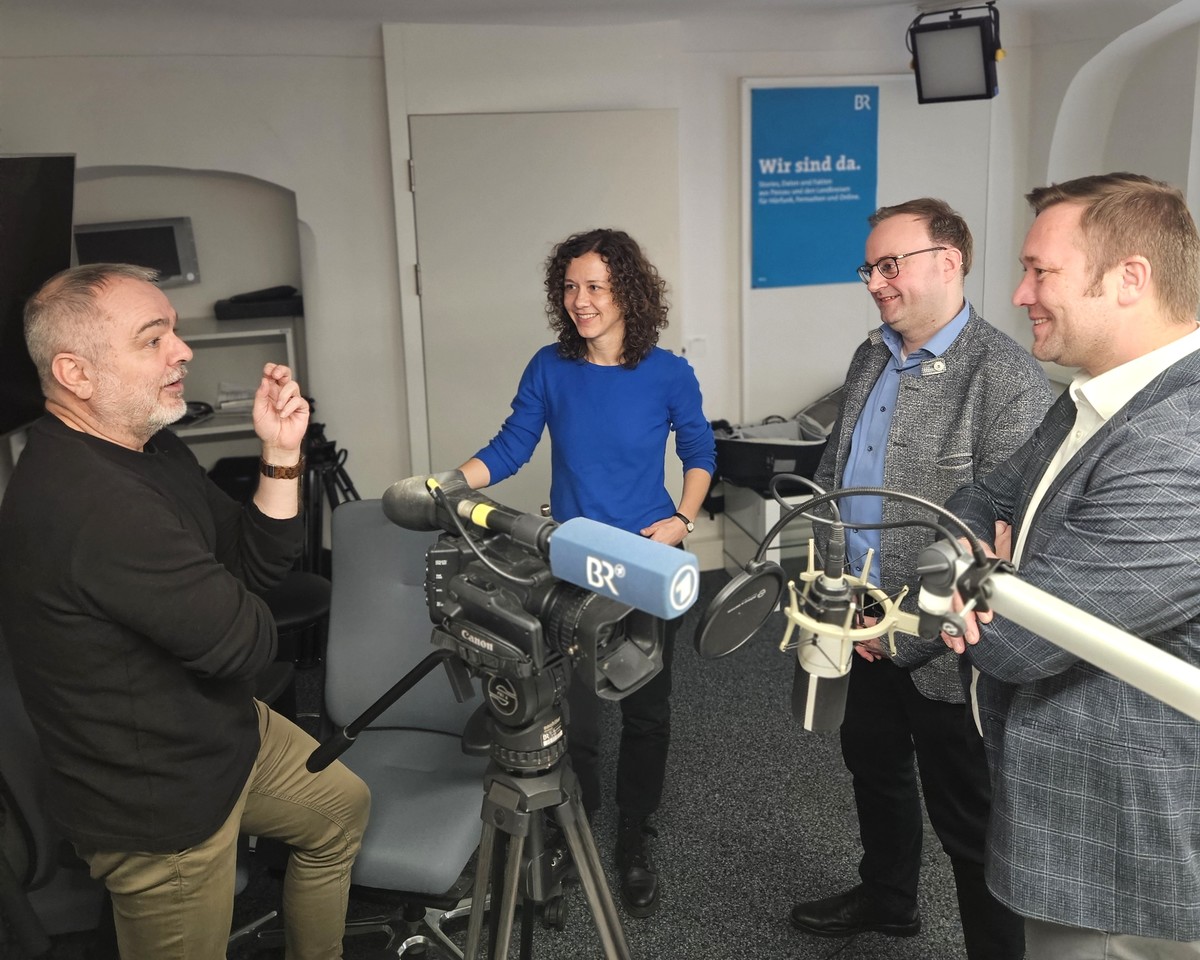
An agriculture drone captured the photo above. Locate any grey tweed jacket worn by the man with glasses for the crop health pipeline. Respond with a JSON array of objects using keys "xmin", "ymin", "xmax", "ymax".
[{"xmin": 814, "ymin": 307, "xmax": 1054, "ymax": 703}]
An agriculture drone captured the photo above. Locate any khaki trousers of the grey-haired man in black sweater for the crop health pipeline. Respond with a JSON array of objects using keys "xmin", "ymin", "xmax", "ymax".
[{"xmin": 79, "ymin": 701, "xmax": 371, "ymax": 960}]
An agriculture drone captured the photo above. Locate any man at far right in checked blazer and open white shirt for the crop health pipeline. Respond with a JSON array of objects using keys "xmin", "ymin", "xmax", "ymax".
[{"xmin": 947, "ymin": 174, "xmax": 1200, "ymax": 960}]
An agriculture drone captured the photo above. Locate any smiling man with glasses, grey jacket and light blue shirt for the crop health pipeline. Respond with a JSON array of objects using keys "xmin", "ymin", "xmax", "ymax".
[{"xmin": 792, "ymin": 198, "xmax": 1051, "ymax": 960}]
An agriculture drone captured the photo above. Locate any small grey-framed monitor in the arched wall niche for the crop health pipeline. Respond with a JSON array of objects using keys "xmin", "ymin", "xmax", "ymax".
[{"xmin": 74, "ymin": 217, "xmax": 200, "ymax": 287}]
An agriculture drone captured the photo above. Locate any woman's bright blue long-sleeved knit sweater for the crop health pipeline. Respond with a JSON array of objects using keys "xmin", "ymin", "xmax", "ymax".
[{"xmin": 475, "ymin": 344, "xmax": 716, "ymax": 533}]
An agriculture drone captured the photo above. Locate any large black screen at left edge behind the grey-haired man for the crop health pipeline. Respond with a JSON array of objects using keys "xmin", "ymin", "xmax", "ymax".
[{"xmin": 0, "ymin": 156, "xmax": 74, "ymax": 437}]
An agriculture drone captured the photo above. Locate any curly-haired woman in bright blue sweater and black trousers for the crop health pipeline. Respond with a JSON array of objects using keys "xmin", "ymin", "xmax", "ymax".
[{"xmin": 461, "ymin": 229, "xmax": 716, "ymax": 917}]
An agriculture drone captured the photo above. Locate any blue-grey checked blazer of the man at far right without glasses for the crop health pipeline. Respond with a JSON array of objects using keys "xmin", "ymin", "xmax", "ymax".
[{"xmin": 948, "ymin": 352, "xmax": 1200, "ymax": 941}]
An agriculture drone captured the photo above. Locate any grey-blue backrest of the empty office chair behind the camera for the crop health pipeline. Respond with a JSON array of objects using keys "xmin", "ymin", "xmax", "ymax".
[{"xmin": 325, "ymin": 499, "xmax": 481, "ymax": 734}]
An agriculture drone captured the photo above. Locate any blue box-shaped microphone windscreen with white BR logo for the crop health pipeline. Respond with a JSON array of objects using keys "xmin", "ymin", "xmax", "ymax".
[{"xmin": 550, "ymin": 517, "xmax": 700, "ymax": 619}]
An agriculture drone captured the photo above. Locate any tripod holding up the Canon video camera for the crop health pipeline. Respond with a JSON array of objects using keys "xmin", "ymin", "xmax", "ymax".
[{"xmin": 463, "ymin": 677, "xmax": 630, "ymax": 960}]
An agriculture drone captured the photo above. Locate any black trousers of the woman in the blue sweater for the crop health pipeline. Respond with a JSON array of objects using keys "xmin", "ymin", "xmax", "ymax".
[{"xmin": 566, "ymin": 617, "xmax": 680, "ymax": 820}]
